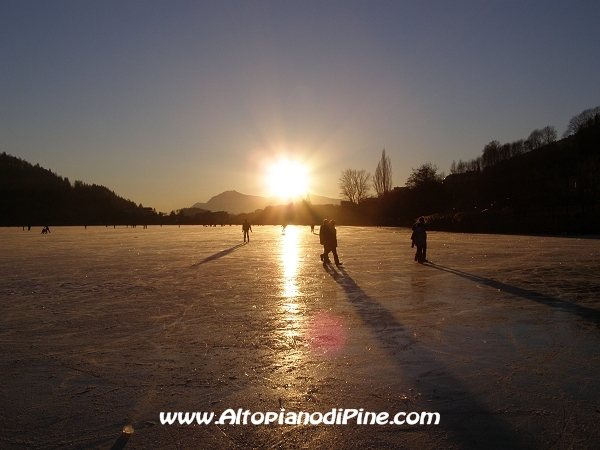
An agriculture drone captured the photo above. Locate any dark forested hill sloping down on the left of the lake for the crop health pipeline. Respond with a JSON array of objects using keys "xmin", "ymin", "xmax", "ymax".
[{"xmin": 0, "ymin": 153, "xmax": 158, "ymax": 226}]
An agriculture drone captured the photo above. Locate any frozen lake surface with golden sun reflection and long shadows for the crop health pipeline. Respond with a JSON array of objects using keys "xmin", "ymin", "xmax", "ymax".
[{"xmin": 0, "ymin": 226, "xmax": 600, "ymax": 449}]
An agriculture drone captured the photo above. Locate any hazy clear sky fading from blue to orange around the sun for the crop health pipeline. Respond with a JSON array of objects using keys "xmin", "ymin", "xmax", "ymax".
[{"xmin": 0, "ymin": 0, "xmax": 600, "ymax": 212}]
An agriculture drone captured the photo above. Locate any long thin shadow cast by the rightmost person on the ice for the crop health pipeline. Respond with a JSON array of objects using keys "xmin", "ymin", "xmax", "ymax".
[{"xmin": 426, "ymin": 263, "xmax": 600, "ymax": 329}]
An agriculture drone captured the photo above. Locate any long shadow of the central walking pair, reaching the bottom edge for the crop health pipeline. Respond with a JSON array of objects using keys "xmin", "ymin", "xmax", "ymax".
[{"xmin": 325, "ymin": 266, "xmax": 532, "ymax": 449}]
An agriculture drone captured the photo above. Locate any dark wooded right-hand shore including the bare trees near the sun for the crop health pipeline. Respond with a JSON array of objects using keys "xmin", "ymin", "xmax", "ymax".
[{"xmin": 339, "ymin": 107, "xmax": 600, "ymax": 233}]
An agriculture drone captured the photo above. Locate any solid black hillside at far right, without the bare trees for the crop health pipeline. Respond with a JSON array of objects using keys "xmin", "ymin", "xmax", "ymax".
[{"xmin": 418, "ymin": 115, "xmax": 600, "ymax": 233}]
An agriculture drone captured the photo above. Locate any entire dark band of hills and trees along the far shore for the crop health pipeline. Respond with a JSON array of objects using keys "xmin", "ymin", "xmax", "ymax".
[{"xmin": 0, "ymin": 107, "xmax": 600, "ymax": 233}]
